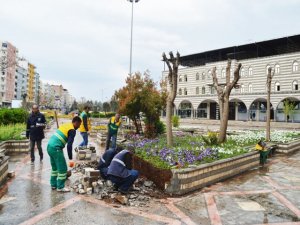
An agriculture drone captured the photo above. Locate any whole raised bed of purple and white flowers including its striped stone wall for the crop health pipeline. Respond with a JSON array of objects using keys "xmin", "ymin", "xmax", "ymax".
[{"xmin": 127, "ymin": 131, "xmax": 299, "ymax": 195}]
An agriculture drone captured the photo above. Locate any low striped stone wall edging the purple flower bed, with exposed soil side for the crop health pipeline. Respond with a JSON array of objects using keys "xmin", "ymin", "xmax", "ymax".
[{"xmin": 134, "ymin": 151, "xmax": 259, "ymax": 195}]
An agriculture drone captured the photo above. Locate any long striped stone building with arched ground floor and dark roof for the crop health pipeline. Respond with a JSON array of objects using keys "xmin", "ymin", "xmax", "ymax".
[{"xmin": 163, "ymin": 35, "xmax": 300, "ymax": 122}]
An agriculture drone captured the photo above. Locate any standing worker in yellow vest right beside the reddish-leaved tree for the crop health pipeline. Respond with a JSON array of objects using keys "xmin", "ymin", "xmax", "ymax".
[{"xmin": 105, "ymin": 113, "xmax": 121, "ymax": 150}]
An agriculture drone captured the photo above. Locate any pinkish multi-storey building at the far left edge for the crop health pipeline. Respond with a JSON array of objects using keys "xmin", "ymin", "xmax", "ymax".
[{"xmin": 0, "ymin": 41, "xmax": 17, "ymax": 106}]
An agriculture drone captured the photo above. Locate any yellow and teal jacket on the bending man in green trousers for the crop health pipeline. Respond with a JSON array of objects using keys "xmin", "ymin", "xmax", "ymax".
[{"xmin": 49, "ymin": 123, "xmax": 75, "ymax": 148}]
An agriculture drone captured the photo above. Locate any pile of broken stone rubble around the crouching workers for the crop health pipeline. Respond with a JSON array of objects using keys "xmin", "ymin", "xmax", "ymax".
[{"xmin": 71, "ymin": 161, "xmax": 164, "ymax": 207}]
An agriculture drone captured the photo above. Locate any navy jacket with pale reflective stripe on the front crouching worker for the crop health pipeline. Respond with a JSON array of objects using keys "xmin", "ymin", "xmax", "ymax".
[{"xmin": 107, "ymin": 150, "xmax": 130, "ymax": 178}]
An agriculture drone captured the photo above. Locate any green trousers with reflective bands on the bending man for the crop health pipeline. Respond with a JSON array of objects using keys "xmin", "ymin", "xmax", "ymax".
[{"xmin": 47, "ymin": 145, "xmax": 68, "ymax": 189}]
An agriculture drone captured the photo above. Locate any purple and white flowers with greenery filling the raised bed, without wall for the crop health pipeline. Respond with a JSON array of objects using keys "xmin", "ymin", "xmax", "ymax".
[{"xmin": 127, "ymin": 131, "xmax": 300, "ymax": 169}]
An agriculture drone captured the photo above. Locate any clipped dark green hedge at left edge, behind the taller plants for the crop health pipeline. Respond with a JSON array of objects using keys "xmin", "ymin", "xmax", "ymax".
[{"xmin": 0, "ymin": 109, "xmax": 28, "ymax": 125}]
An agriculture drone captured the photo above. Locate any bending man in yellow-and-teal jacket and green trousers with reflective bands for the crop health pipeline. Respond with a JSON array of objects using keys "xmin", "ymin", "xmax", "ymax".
[{"xmin": 47, "ymin": 116, "xmax": 81, "ymax": 192}]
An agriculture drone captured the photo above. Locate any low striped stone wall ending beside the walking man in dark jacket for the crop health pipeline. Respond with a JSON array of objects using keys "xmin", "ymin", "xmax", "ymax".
[{"xmin": 0, "ymin": 140, "xmax": 29, "ymax": 155}]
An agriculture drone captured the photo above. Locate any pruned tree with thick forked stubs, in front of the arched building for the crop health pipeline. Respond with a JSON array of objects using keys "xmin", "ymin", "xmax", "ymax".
[{"xmin": 212, "ymin": 59, "xmax": 242, "ymax": 143}]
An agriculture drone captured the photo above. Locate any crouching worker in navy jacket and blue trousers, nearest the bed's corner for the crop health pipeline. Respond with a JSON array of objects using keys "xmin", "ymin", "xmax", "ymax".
[{"xmin": 107, "ymin": 150, "xmax": 139, "ymax": 194}]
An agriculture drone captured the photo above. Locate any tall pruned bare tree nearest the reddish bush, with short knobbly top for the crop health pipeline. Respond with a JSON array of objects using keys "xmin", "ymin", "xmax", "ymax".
[{"xmin": 162, "ymin": 52, "xmax": 180, "ymax": 146}]
